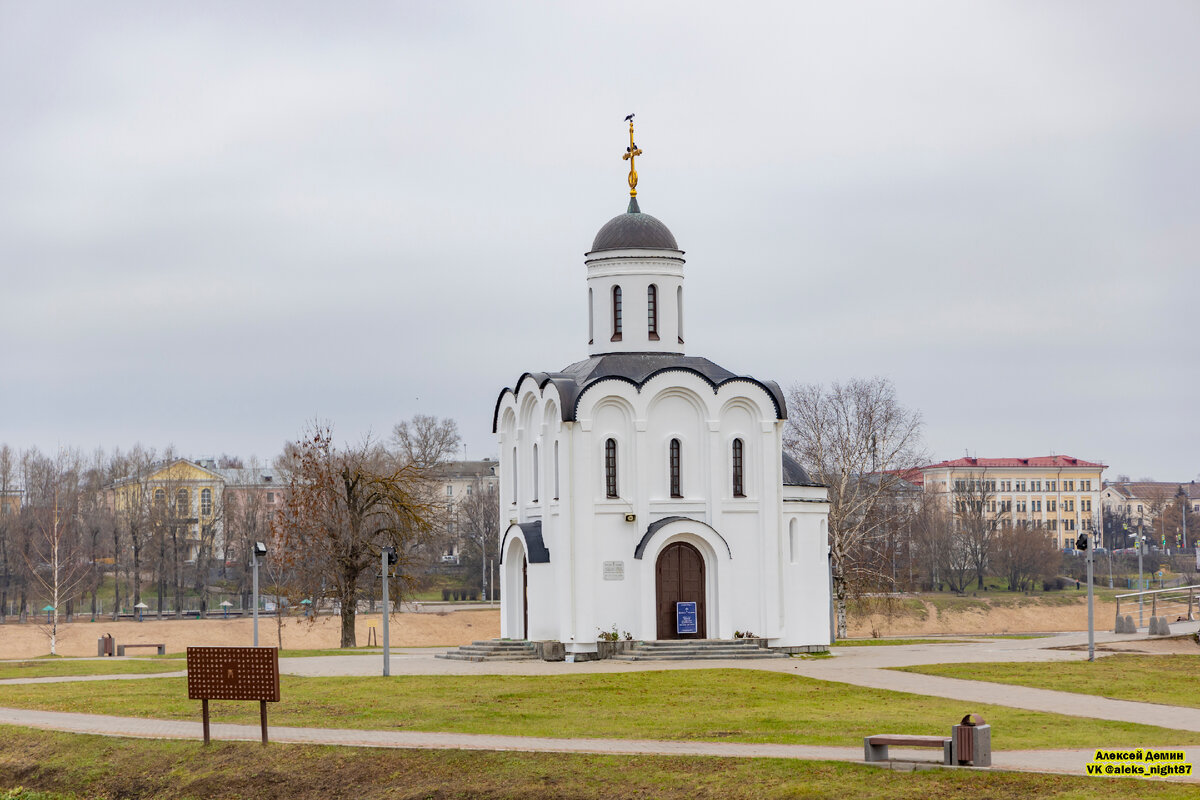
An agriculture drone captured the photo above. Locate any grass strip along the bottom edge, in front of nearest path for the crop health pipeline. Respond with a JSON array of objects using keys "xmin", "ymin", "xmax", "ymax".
[{"xmin": 0, "ymin": 727, "xmax": 1195, "ymax": 800}]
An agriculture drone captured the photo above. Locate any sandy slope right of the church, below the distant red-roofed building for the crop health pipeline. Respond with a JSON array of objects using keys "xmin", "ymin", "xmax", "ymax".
[{"xmin": 848, "ymin": 601, "xmax": 1124, "ymax": 637}]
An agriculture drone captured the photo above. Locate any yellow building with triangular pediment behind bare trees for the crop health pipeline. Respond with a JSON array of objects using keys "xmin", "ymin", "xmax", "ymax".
[{"xmin": 108, "ymin": 458, "xmax": 224, "ymax": 561}]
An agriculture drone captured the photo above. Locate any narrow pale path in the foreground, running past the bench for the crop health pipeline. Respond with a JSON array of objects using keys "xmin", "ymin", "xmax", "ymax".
[{"xmin": 0, "ymin": 708, "xmax": 1200, "ymax": 783}]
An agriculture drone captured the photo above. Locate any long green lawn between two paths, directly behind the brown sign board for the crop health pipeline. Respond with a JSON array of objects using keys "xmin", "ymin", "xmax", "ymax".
[{"xmin": 0, "ymin": 669, "xmax": 1200, "ymax": 750}]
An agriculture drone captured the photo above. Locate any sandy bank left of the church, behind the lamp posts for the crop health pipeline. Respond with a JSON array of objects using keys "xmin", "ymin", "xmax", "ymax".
[{"xmin": 0, "ymin": 608, "xmax": 500, "ymax": 660}]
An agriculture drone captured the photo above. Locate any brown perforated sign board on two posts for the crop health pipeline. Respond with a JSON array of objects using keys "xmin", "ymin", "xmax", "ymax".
[{"xmin": 187, "ymin": 648, "xmax": 280, "ymax": 745}]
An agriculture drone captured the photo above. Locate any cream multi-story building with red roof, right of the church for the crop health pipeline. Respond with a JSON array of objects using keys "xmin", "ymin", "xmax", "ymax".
[{"xmin": 920, "ymin": 456, "xmax": 1106, "ymax": 547}]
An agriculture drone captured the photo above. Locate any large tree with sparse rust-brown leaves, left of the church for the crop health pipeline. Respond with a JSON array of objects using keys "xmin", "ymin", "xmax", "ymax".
[{"xmin": 274, "ymin": 423, "xmax": 431, "ymax": 648}]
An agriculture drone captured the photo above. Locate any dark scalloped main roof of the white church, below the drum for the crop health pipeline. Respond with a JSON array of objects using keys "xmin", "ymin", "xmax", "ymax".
[{"xmin": 492, "ymin": 353, "xmax": 804, "ymax": 434}]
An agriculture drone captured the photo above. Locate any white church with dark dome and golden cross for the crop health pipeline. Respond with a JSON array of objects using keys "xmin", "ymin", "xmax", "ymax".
[{"xmin": 493, "ymin": 122, "xmax": 829, "ymax": 660}]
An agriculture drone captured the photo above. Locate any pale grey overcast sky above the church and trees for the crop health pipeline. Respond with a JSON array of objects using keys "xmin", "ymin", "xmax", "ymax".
[{"xmin": 0, "ymin": 1, "xmax": 1200, "ymax": 480}]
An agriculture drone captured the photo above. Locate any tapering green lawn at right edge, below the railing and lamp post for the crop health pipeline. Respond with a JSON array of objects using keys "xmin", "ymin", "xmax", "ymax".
[{"xmin": 896, "ymin": 654, "xmax": 1200, "ymax": 708}]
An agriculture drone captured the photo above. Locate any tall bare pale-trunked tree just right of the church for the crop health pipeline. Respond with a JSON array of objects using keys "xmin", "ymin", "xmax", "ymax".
[{"xmin": 784, "ymin": 378, "xmax": 924, "ymax": 637}]
